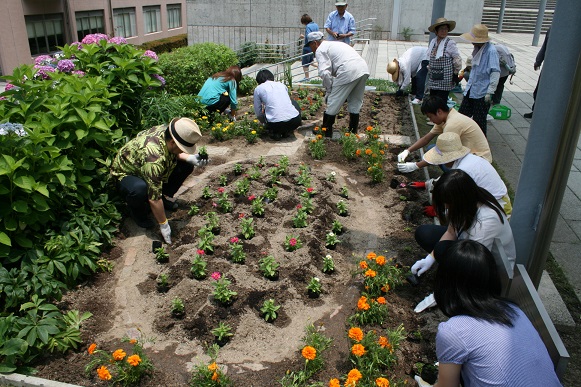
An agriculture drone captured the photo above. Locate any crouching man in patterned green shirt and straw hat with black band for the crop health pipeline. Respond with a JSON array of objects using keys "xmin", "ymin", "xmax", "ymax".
[{"xmin": 111, "ymin": 117, "xmax": 208, "ymax": 243}]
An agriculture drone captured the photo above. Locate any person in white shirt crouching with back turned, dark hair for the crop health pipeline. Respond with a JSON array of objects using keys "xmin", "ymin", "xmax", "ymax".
[{"xmin": 254, "ymin": 70, "xmax": 302, "ymax": 140}]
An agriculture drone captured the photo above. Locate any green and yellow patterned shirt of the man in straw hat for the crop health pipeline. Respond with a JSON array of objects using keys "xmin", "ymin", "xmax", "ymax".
[{"xmin": 111, "ymin": 125, "xmax": 177, "ymax": 200}]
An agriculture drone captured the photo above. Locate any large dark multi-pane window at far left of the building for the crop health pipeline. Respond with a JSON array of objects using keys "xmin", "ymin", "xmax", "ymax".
[{"xmin": 24, "ymin": 13, "xmax": 65, "ymax": 55}]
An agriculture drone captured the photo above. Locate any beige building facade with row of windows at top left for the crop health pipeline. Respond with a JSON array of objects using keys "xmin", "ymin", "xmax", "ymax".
[{"xmin": 0, "ymin": 0, "xmax": 186, "ymax": 74}]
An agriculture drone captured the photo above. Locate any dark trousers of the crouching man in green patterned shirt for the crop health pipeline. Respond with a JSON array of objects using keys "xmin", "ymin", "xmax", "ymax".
[{"xmin": 117, "ymin": 160, "xmax": 194, "ymax": 218}]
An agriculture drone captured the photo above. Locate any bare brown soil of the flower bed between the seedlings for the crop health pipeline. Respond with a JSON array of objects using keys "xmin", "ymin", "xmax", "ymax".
[{"xmin": 36, "ymin": 93, "xmax": 443, "ymax": 387}]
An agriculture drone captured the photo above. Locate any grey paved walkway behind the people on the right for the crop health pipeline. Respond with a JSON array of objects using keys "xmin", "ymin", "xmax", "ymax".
[{"xmin": 370, "ymin": 33, "xmax": 581, "ymax": 325}]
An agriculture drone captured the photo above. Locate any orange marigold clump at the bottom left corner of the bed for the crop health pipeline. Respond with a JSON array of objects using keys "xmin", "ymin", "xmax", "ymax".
[{"xmin": 85, "ymin": 337, "xmax": 153, "ymax": 386}]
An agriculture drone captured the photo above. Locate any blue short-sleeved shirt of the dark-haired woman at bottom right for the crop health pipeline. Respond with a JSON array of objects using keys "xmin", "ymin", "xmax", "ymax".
[{"xmin": 436, "ymin": 306, "xmax": 561, "ymax": 387}]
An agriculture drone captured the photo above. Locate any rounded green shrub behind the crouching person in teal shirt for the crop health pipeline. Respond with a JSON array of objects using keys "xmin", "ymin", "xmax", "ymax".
[{"xmin": 159, "ymin": 43, "xmax": 238, "ymax": 95}]
